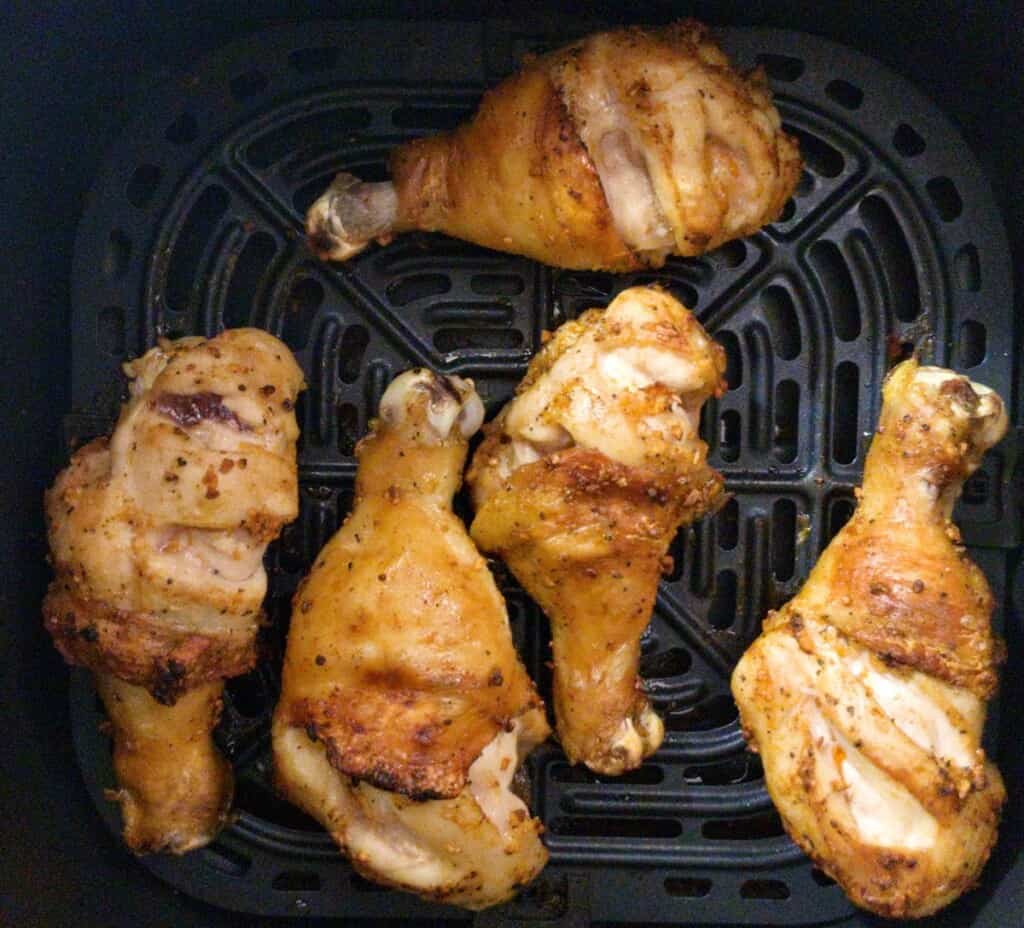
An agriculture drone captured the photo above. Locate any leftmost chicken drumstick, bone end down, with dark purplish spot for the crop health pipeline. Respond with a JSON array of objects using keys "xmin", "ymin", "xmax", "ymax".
[{"xmin": 43, "ymin": 329, "xmax": 302, "ymax": 853}]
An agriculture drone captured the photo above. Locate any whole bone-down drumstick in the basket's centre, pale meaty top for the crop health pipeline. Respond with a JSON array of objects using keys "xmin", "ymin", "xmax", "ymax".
[{"xmin": 467, "ymin": 287, "xmax": 725, "ymax": 774}]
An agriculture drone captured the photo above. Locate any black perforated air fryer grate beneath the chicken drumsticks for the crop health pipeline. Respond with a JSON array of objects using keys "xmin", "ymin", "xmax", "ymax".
[{"xmin": 66, "ymin": 23, "xmax": 1020, "ymax": 925}]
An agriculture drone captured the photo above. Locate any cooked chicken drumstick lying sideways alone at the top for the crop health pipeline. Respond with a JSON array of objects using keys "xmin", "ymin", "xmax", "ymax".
[{"xmin": 306, "ymin": 20, "xmax": 801, "ymax": 270}]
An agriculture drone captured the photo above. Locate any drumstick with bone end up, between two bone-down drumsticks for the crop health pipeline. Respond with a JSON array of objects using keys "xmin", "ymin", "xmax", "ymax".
[{"xmin": 273, "ymin": 370, "xmax": 549, "ymax": 909}]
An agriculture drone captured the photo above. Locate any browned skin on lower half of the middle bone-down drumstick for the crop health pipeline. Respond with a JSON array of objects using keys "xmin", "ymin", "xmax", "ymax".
[{"xmin": 473, "ymin": 444, "xmax": 722, "ymax": 773}]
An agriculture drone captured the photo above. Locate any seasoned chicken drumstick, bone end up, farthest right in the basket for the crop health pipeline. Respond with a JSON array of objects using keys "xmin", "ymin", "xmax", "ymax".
[{"xmin": 732, "ymin": 361, "xmax": 1007, "ymax": 918}]
